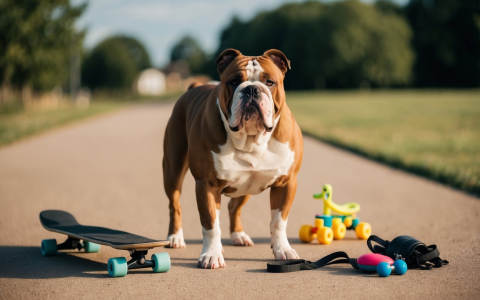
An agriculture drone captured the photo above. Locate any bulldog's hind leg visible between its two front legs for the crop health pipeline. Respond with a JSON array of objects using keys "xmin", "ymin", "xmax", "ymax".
[{"xmin": 228, "ymin": 195, "xmax": 253, "ymax": 246}]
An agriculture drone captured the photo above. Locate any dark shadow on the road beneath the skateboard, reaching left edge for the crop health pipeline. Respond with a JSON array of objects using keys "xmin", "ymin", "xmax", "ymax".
[{"xmin": 0, "ymin": 246, "xmax": 108, "ymax": 279}]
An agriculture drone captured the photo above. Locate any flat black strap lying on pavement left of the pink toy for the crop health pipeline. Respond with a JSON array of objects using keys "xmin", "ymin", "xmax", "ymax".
[{"xmin": 267, "ymin": 251, "xmax": 358, "ymax": 273}]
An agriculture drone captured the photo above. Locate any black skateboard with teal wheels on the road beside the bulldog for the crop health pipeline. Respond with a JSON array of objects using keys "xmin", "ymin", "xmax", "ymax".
[{"xmin": 40, "ymin": 210, "xmax": 171, "ymax": 277}]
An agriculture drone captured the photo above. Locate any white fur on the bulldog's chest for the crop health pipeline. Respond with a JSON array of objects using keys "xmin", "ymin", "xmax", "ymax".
[{"xmin": 212, "ymin": 99, "xmax": 294, "ymax": 197}]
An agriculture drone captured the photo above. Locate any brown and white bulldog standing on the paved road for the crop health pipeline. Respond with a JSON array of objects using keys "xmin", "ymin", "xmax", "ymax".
[{"xmin": 163, "ymin": 49, "xmax": 303, "ymax": 269}]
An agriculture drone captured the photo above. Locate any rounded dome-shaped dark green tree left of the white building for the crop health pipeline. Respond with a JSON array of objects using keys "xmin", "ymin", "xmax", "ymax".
[{"xmin": 82, "ymin": 36, "xmax": 151, "ymax": 89}]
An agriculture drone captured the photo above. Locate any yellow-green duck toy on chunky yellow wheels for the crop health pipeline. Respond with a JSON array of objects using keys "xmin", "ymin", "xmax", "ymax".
[{"xmin": 299, "ymin": 184, "xmax": 372, "ymax": 245}]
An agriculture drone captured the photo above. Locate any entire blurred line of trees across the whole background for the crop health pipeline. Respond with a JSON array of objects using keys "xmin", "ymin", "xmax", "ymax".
[{"xmin": 0, "ymin": 0, "xmax": 480, "ymax": 101}]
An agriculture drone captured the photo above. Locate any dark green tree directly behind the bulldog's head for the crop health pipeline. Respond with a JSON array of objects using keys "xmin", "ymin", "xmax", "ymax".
[{"xmin": 213, "ymin": 1, "xmax": 325, "ymax": 89}]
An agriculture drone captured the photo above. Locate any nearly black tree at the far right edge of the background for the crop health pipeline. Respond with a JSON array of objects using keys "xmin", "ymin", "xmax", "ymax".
[{"xmin": 406, "ymin": 0, "xmax": 480, "ymax": 87}]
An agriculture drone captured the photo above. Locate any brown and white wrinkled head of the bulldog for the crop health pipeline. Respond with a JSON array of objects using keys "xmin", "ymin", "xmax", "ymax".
[{"xmin": 216, "ymin": 49, "xmax": 290, "ymax": 136}]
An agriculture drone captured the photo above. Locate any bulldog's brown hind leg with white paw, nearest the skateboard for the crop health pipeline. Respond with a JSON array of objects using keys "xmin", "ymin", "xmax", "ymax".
[{"xmin": 163, "ymin": 112, "xmax": 188, "ymax": 248}]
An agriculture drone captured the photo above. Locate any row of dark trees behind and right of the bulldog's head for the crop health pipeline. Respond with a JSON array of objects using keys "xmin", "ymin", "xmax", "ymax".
[{"xmin": 191, "ymin": 0, "xmax": 480, "ymax": 89}]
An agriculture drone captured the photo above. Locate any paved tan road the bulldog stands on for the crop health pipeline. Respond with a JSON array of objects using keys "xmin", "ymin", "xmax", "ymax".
[{"xmin": 0, "ymin": 104, "xmax": 480, "ymax": 299}]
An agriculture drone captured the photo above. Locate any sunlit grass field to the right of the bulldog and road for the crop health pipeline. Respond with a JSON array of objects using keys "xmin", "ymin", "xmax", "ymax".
[{"xmin": 287, "ymin": 90, "xmax": 480, "ymax": 195}]
